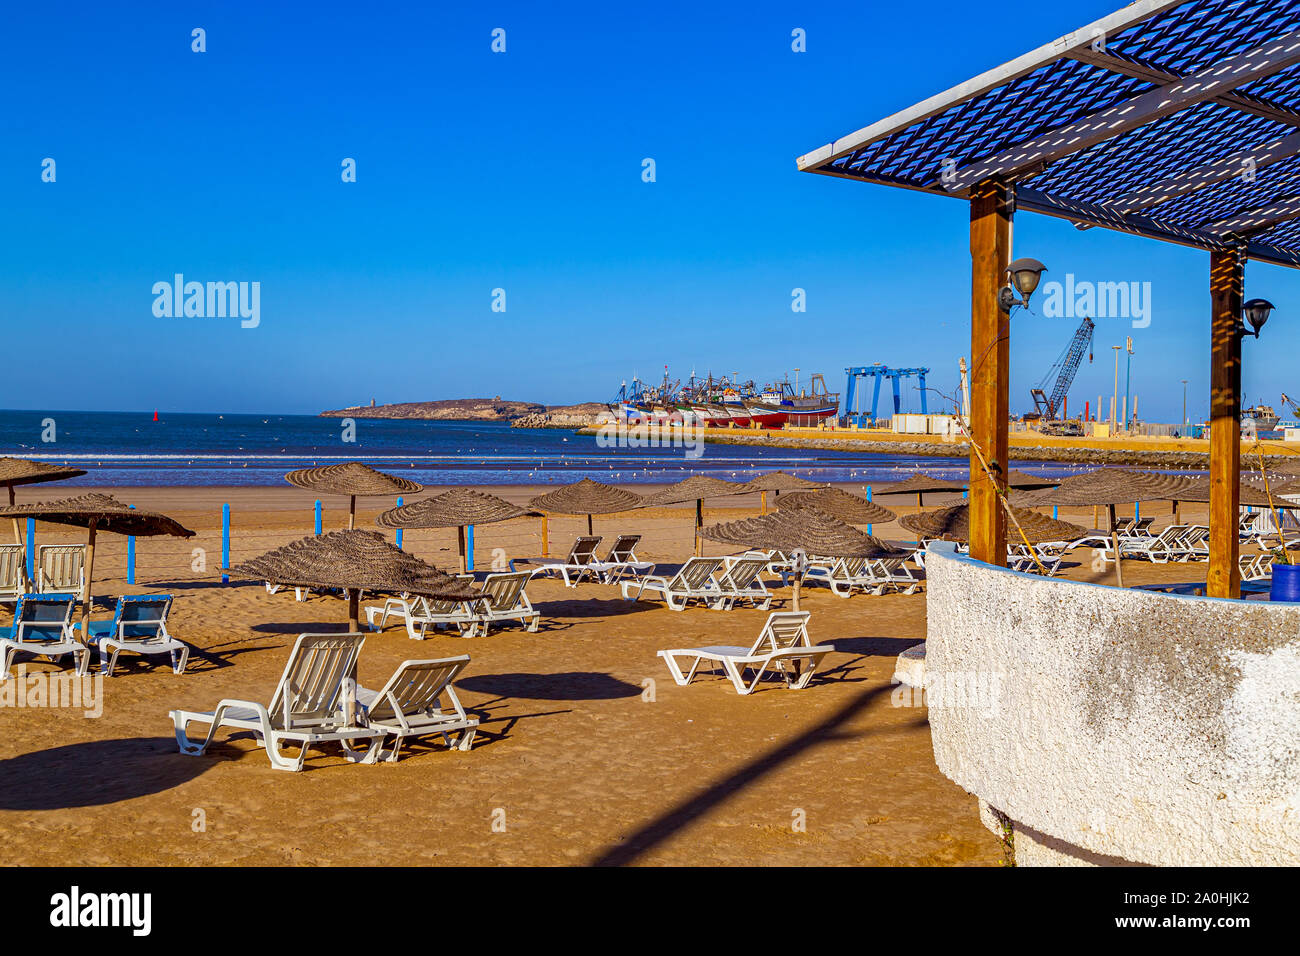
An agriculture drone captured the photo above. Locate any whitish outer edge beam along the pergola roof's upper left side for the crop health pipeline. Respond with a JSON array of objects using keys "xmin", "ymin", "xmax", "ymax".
[{"xmin": 796, "ymin": 0, "xmax": 1187, "ymax": 169}]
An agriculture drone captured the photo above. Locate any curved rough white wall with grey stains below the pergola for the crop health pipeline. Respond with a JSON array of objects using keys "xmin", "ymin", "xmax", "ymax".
[{"xmin": 924, "ymin": 546, "xmax": 1300, "ymax": 865}]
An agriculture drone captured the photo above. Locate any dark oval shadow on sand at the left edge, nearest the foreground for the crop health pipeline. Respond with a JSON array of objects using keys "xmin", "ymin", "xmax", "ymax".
[{"xmin": 0, "ymin": 737, "xmax": 213, "ymax": 810}]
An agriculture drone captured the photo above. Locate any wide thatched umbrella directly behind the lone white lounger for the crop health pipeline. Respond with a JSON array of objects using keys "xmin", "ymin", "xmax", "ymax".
[{"xmin": 699, "ymin": 507, "xmax": 910, "ymax": 610}]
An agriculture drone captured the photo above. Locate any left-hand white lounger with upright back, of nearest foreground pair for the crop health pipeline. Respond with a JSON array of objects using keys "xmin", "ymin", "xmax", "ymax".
[{"xmin": 170, "ymin": 633, "xmax": 382, "ymax": 770}]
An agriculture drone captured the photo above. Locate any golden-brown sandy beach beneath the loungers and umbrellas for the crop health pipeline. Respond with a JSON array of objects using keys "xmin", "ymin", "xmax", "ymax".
[{"xmin": 0, "ymin": 486, "xmax": 1237, "ymax": 866}]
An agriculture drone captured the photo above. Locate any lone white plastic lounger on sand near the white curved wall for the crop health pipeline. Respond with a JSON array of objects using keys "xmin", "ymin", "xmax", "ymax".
[{"xmin": 659, "ymin": 611, "xmax": 835, "ymax": 695}]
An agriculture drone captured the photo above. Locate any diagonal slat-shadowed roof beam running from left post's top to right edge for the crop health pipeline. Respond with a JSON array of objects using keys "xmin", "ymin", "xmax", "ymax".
[{"xmin": 945, "ymin": 31, "xmax": 1300, "ymax": 193}]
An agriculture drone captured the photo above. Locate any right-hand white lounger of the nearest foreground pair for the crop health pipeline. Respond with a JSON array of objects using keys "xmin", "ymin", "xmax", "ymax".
[{"xmin": 356, "ymin": 654, "xmax": 478, "ymax": 763}]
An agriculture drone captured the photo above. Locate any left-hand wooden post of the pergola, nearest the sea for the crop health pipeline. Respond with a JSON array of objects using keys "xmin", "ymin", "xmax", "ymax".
[{"xmin": 972, "ymin": 179, "xmax": 1011, "ymax": 566}]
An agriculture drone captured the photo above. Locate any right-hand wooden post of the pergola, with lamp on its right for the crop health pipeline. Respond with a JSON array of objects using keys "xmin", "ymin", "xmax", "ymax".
[{"xmin": 1205, "ymin": 250, "xmax": 1244, "ymax": 597}]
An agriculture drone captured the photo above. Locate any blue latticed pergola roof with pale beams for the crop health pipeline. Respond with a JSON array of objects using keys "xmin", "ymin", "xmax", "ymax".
[{"xmin": 798, "ymin": 0, "xmax": 1300, "ymax": 268}]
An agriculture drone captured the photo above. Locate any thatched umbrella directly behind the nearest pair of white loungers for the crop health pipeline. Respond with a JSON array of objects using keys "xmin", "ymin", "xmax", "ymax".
[{"xmin": 233, "ymin": 531, "xmax": 484, "ymax": 631}]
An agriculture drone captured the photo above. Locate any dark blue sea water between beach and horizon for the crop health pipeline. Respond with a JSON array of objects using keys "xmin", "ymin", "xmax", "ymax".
[{"xmin": 0, "ymin": 411, "xmax": 1062, "ymax": 486}]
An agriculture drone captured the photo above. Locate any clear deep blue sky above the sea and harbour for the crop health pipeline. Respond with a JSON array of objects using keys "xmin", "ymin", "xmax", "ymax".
[{"xmin": 0, "ymin": 0, "xmax": 1300, "ymax": 420}]
